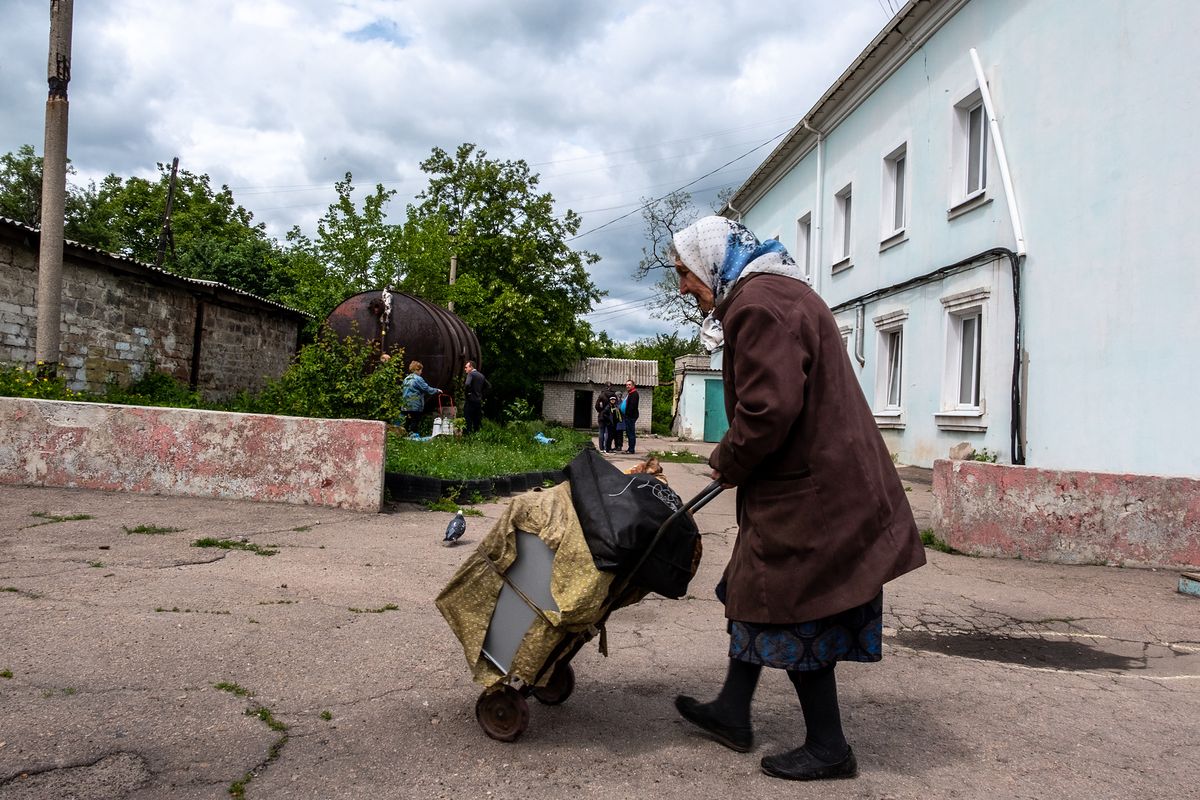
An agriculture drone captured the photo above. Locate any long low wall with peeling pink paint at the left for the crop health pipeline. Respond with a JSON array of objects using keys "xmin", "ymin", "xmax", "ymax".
[{"xmin": 0, "ymin": 397, "xmax": 385, "ymax": 511}]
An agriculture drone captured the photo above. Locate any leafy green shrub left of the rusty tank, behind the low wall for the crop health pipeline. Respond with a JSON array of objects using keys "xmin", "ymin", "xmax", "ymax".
[{"xmin": 229, "ymin": 326, "xmax": 404, "ymax": 422}]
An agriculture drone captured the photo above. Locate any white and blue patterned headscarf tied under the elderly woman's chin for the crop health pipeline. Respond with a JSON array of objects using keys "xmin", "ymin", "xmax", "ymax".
[{"xmin": 672, "ymin": 216, "xmax": 809, "ymax": 353}]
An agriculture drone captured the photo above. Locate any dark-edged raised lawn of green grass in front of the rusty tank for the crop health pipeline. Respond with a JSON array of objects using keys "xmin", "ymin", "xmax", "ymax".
[{"xmin": 388, "ymin": 421, "xmax": 592, "ymax": 480}]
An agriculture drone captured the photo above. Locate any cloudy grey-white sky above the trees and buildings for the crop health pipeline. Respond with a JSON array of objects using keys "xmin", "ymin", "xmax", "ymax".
[{"xmin": 0, "ymin": 0, "xmax": 901, "ymax": 341}]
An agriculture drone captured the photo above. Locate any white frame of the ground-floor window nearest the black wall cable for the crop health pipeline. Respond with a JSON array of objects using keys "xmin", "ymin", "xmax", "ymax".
[{"xmin": 935, "ymin": 288, "xmax": 992, "ymax": 431}]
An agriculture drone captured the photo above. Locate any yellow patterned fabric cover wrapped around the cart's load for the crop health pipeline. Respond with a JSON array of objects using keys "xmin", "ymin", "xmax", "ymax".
[{"xmin": 436, "ymin": 482, "xmax": 613, "ymax": 687}]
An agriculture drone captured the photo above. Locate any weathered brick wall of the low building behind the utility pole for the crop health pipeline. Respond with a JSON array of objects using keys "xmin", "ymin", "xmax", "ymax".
[{"xmin": 0, "ymin": 223, "xmax": 304, "ymax": 399}]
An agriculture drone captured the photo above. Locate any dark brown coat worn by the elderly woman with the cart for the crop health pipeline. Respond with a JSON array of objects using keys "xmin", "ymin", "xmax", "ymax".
[{"xmin": 709, "ymin": 273, "xmax": 925, "ymax": 624}]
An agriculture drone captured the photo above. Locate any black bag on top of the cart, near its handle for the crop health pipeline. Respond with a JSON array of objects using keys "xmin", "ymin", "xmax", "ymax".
[{"xmin": 564, "ymin": 447, "xmax": 700, "ymax": 599}]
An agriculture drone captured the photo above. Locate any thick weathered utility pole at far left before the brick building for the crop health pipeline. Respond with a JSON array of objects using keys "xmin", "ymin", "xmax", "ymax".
[{"xmin": 34, "ymin": 0, "xmax": 74, "ymax": 375}]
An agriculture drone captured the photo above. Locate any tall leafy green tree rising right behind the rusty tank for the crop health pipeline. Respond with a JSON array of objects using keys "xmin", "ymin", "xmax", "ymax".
[{"xmin": 400, "ymin": 144, "xmax": 601, "ymax": 410}]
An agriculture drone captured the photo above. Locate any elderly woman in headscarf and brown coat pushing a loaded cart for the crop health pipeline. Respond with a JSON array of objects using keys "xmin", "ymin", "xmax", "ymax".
[{"xmin": 672, "ymin": 217, "xmax": 925, "ymax": 781}]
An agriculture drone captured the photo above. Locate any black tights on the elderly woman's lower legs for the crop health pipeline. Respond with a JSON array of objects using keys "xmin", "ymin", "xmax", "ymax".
[{"xmin": 709, "ymin": 658, "xmax": 848, "ymax": 762}]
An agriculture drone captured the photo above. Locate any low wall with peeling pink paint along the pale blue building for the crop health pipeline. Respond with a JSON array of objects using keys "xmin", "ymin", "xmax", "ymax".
[{"xmin": 934, "ymin": 459, "xmax": 1200, "ymax": 566}]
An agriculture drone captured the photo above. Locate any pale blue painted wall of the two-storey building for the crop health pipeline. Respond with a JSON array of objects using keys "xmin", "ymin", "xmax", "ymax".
[{"xmin": 739, "ymin": 0, "xmax": 1200, "ymax": 477}]
